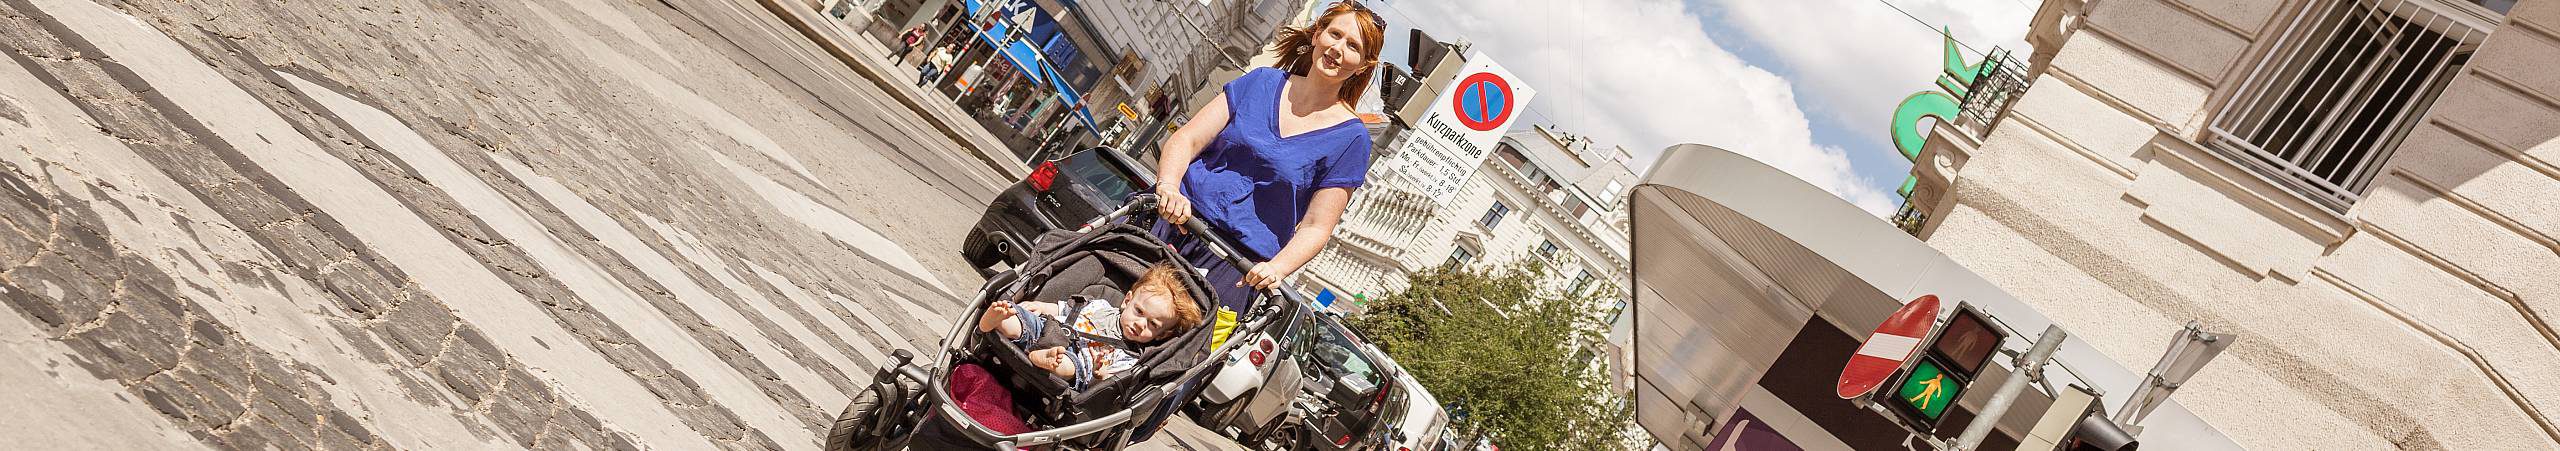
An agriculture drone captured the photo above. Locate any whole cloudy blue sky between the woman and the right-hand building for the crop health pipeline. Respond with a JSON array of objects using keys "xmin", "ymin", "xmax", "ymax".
[{"xmin": 1364, "ymin": 0, "xmax": 2038, "ymax": 215}]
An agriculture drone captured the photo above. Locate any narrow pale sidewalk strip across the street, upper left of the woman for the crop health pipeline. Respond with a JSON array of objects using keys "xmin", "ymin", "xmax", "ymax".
[{"xmin": 735, "ymin": 0, "xmax": 1032, "ymax": 179}]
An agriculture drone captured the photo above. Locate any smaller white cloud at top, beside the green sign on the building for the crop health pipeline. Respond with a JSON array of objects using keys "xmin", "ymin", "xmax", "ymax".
[{"xmin": 1710, "ymin": 0, "xmax": 2035, "ymax": 141}]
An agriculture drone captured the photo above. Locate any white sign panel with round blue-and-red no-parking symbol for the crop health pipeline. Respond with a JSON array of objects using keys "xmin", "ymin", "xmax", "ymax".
[{"xmin": 1390, "ymin": 54, "xmax": 1539, "ymax": 202}]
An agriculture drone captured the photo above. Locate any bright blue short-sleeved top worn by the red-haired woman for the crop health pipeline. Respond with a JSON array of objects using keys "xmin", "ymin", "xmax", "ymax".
[{"xmin": 1183, "ymin": 67, "xmax": 1370, "ymax": 261}]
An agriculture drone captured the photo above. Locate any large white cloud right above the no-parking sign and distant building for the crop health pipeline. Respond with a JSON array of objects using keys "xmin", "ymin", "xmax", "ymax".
[{"xmin": 1390, "ymin": 0, "xmax": 1925, "ymax": 215}]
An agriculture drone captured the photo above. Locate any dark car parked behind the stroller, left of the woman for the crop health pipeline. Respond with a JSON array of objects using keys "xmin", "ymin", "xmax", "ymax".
[{"xmin": 960, "ymin": 146, "xmax": 1155, "ymax": 274}]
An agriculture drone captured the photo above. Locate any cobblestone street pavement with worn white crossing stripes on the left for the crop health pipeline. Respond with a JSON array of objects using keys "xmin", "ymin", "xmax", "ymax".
[{"xmin": 0, "ymin": 0, "xmax": 1080, "ymax": 448}]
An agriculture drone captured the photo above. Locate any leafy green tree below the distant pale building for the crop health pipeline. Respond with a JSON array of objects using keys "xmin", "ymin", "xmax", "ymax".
[{"xmin": 1349, "ymin": 264, "xmax": 1633, "ymax": 451}]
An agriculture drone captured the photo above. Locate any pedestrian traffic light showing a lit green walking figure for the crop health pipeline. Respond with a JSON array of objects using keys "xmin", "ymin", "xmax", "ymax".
[{"xmin": 1876, "ymin": 302, "xmax": 2007, "ymax": 433}]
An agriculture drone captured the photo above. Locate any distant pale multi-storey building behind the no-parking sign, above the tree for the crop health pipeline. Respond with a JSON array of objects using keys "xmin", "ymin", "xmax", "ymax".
[{"xmin": 1298, "ymin": 126, "xmax": 1636, "ymax": 305}]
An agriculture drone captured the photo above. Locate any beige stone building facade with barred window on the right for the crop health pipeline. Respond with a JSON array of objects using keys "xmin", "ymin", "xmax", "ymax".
[{"xmin": 1907, "ymin": 0, "xmax": 2560, "ymax": 448}]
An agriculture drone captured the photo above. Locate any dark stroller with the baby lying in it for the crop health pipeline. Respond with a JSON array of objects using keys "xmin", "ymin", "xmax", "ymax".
[{"xmin": 827, "ymin": 195, "xmax": 1303, "ymax": 451}]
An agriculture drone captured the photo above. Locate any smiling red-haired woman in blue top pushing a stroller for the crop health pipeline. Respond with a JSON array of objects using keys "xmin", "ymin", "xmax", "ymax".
[{"xmin": 1155, "ymin": 3, "xmax": 1385, "ymax": 310}]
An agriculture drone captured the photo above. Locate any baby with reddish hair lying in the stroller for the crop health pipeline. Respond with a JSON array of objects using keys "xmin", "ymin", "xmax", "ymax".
[{"xmin": 978, "ymin": 264, "xmax": 1201, "ymax": 390}]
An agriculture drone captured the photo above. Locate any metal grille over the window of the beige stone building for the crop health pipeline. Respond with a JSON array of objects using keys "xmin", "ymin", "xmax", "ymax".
[{"xmin": 2207, "ymin": 0, "xmax": 2493, "ymax": 213}]
